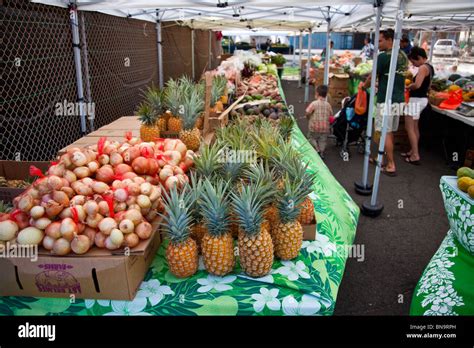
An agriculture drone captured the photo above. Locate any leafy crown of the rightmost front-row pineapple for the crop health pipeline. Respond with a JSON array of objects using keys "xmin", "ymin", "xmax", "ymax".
[{"xmin": 276, "ymin": 175, "xmax": 311, "ymax": 223}]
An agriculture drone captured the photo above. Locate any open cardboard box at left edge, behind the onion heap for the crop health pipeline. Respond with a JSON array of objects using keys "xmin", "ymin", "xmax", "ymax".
[{"xmin": 0, "ymin": 161, "xmax": 50, "ymax": 203}]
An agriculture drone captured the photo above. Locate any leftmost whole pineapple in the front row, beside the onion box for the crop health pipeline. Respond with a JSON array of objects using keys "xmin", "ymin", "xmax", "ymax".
[{"xmin": 160, "ymin": 186, "xmax": 199, "ymax": 278}]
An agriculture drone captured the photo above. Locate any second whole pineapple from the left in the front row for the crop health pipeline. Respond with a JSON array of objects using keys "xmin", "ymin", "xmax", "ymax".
[{"xmin": 201, "ymin": 179, "xmax": 235, "ymax": 276}]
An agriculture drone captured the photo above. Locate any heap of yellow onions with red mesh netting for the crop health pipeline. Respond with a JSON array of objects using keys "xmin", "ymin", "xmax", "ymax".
[{"xmin": 0, "ymin": 134, "xmax": 194, "ymax": 255}]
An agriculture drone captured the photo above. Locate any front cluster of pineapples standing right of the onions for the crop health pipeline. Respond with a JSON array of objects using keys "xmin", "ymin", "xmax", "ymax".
[{"xmin": 163, "ymin": 115, "xmax": 314, "ymax": 278}]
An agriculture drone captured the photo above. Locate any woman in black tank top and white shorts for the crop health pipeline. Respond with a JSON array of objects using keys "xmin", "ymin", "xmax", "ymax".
[{"xmin": 402, "ymin": 46, "xmax": 434, "ymax": 165}]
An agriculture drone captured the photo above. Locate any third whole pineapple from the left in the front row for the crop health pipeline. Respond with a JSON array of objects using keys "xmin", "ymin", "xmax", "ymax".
[{"xmin": 231, "ymin": 183, "xmax": 273, "ymax": 277}]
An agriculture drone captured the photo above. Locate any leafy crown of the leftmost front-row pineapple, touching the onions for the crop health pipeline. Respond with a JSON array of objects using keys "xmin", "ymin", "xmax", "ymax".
[{"xmin": 160, "ymin": 187, "xmax": 193, "ymax": 244}]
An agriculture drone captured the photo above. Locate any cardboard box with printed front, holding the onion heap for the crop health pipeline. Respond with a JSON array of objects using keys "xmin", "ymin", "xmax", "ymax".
[{"xmin": 0, "ymin": 219, "xmax": 161, "ymax": 300}]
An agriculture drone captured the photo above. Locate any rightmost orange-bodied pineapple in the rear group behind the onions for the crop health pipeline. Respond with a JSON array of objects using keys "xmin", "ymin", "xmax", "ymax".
[{"xmin": 179, "ymin": 80, "xmax": 204, "ymax": 151}]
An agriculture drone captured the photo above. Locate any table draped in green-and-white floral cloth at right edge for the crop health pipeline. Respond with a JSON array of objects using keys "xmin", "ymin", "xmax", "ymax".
[{"xmin": 410, "ymin": 176, "xmax": 474, "ymax": 315}]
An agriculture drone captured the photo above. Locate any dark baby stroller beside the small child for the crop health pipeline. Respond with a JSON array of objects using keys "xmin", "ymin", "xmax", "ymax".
[{"xmin": 332, "ymin": 94, "xmax": 368, "ymax": 160}]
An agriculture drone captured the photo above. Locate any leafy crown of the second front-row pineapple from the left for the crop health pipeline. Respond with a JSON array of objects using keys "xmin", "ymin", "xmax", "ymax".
[{"xmin": 199, "ymin": 179, "xmax": 230, "ymax": 237}]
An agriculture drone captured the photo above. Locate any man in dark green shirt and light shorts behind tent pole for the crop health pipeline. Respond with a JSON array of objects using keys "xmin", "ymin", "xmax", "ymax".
[{"xmin": 365, "ymin": 29, "xmax": 408, "ymax": 176}]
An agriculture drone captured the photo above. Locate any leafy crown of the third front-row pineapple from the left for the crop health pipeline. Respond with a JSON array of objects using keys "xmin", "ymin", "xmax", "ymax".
[{"xmin": 230, "ymin": 183, "xmax": 265, "ymax": 236}]
